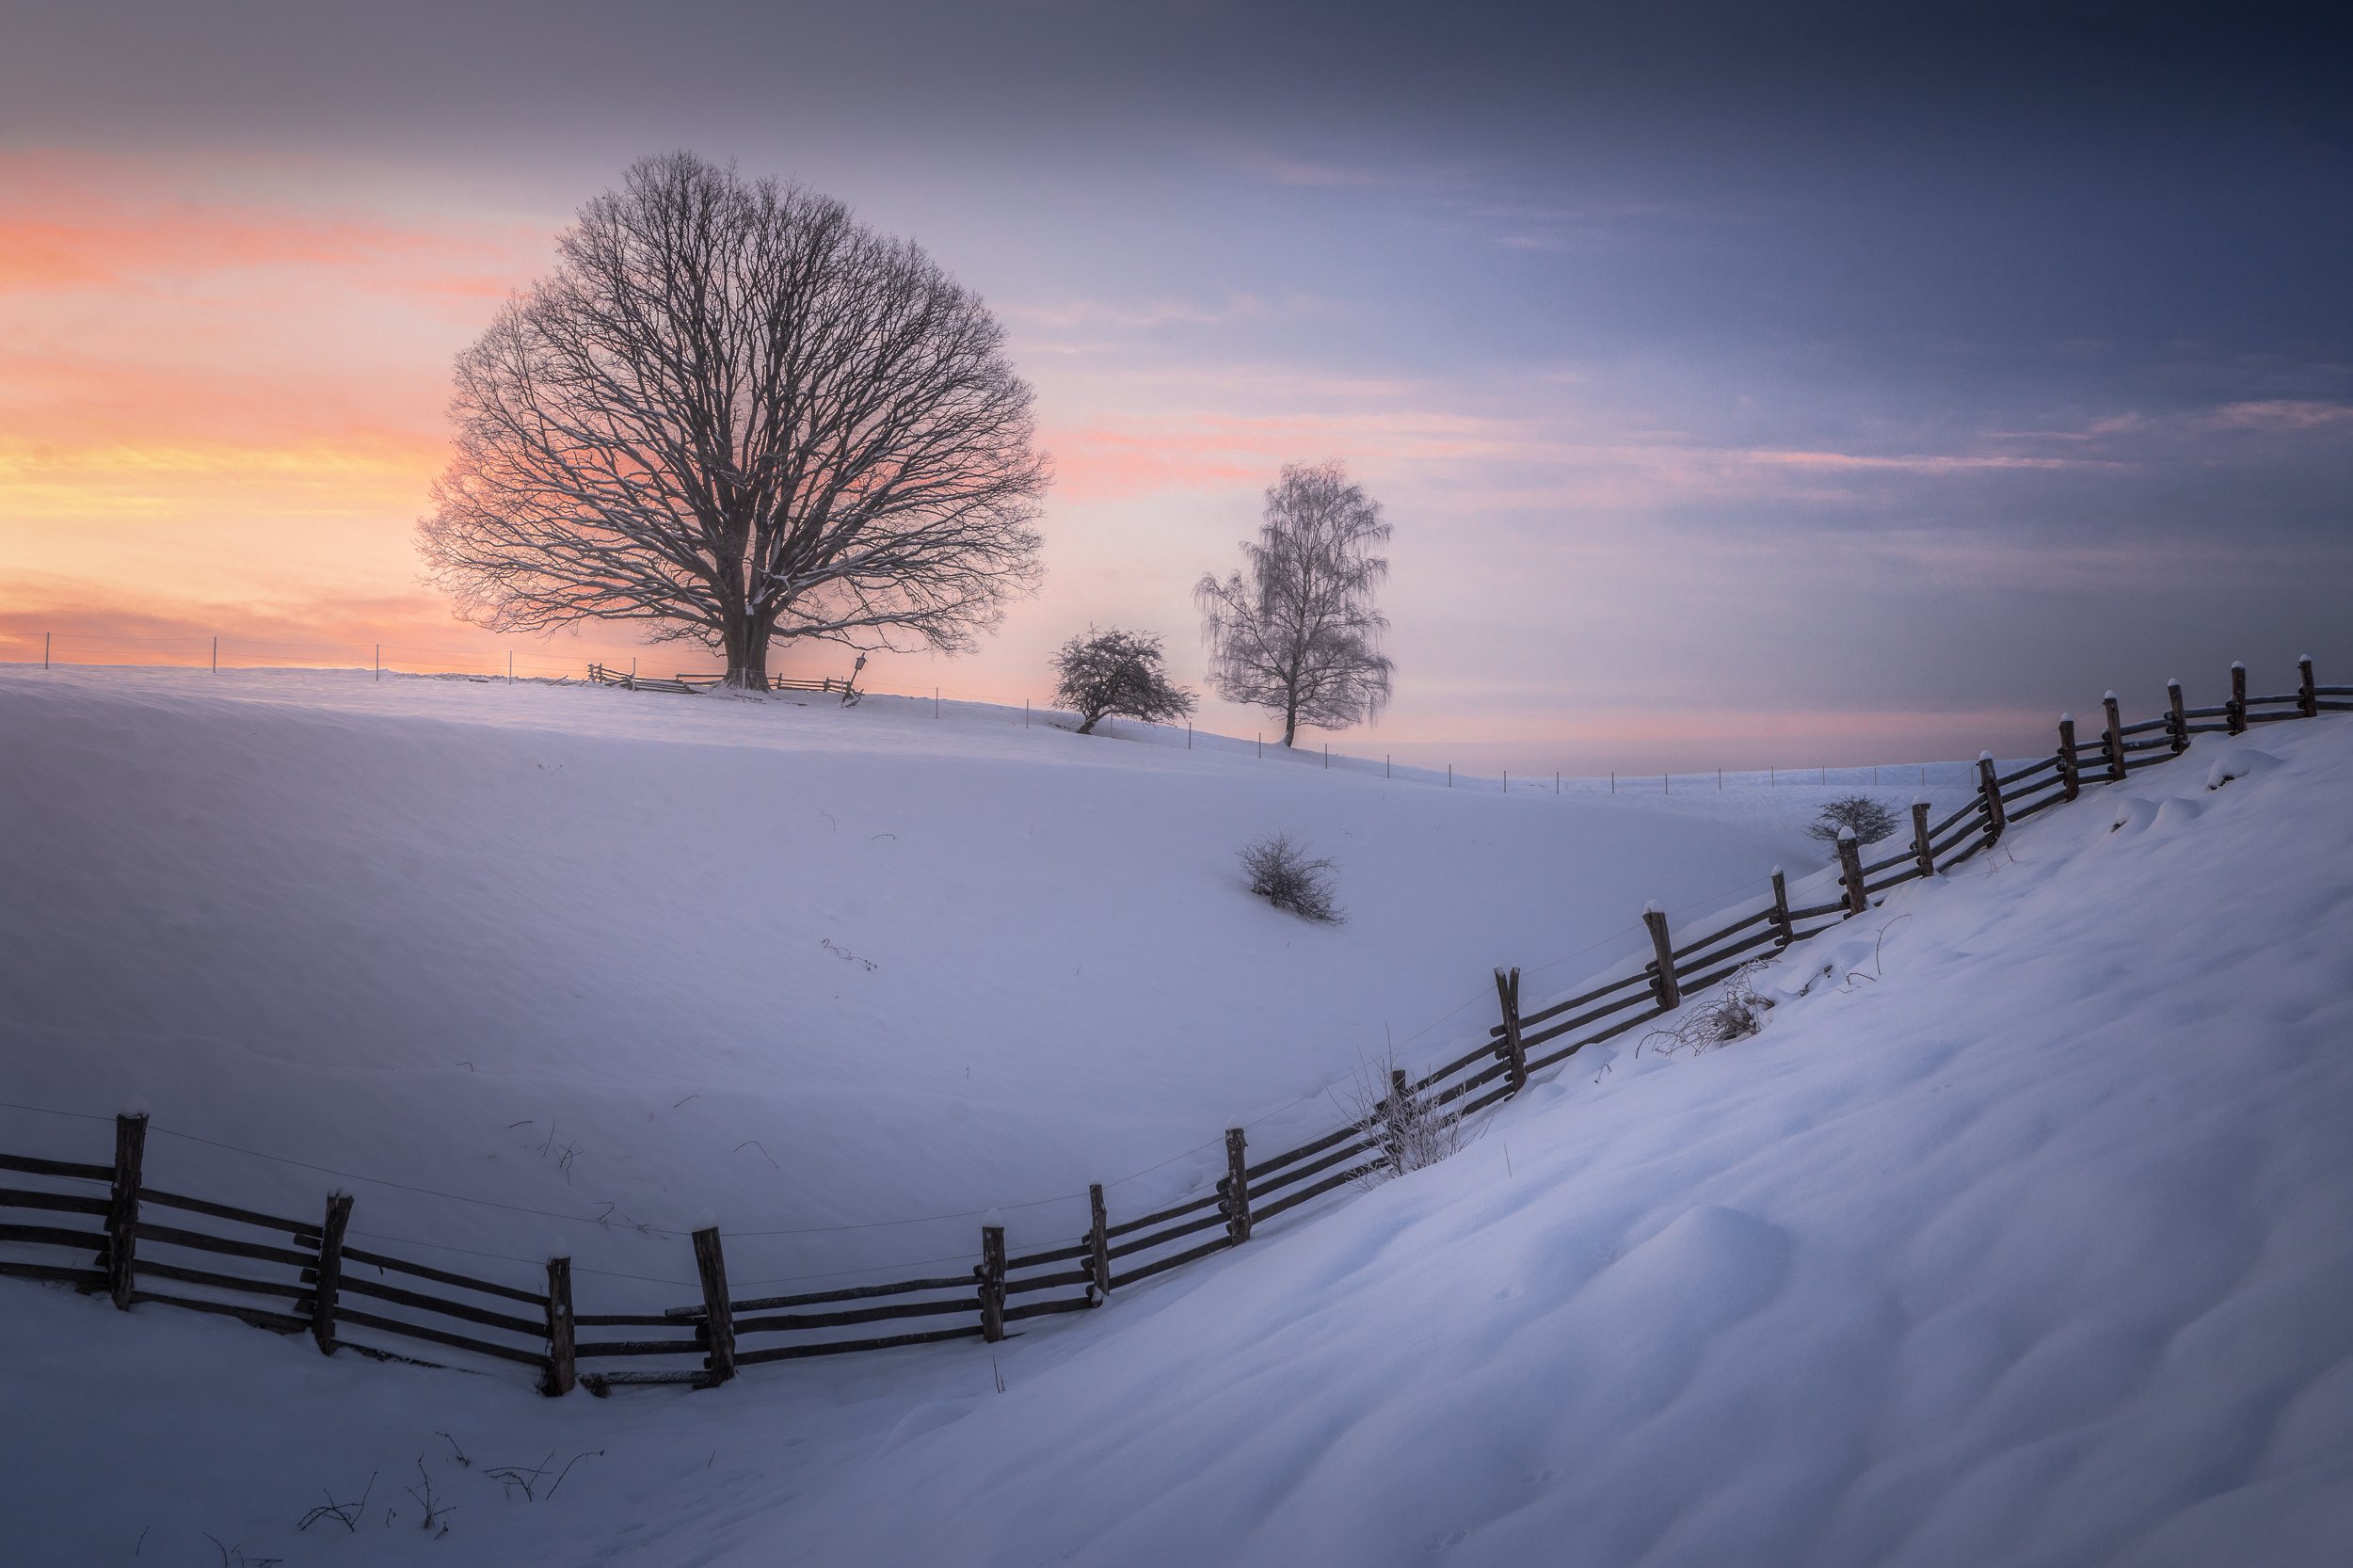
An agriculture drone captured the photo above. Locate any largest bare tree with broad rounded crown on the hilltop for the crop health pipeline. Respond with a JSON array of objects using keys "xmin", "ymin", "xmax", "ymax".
[{"xmin": 419, "ymin": 153, "xmax": 1048, "ymax": 685}]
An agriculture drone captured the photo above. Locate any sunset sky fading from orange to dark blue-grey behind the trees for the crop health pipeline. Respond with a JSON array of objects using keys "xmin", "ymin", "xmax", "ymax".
[{"xmin": 0, "ymin": 0, "xmax": 2353, "ymax": 772}]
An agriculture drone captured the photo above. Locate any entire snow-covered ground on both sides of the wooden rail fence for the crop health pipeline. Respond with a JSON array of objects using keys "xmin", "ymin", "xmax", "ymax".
[{"xmin": 0, "ymin": 676, "xmax": 2353, "ymax": 1568}]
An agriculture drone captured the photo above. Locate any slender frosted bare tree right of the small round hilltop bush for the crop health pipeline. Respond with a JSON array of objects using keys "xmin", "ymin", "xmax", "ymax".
[{"xmin": 1193, "ymin": 461, "xmax": 1393, "ymax": 746}]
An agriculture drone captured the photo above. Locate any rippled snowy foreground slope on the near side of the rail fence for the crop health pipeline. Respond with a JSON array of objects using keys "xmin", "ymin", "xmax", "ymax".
[{"xmin": 0, "ymin": 664, "xmax": 2353, "ymax": 1568}]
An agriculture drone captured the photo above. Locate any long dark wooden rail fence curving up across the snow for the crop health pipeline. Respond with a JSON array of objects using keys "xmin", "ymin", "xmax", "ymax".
[{"xmin": 0, "ymin": 659, "xmax": 2353, "ymax": 1394}]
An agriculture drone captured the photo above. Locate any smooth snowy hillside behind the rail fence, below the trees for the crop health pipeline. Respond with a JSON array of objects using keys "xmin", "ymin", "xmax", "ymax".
[{"xmin": 0, "ymin": 668, "xmax": 1901, "ymax": 1309}]
